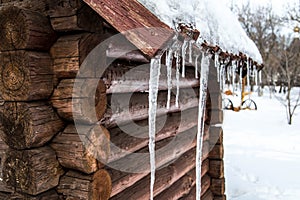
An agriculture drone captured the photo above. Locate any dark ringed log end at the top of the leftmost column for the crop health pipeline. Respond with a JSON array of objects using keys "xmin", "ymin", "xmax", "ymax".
[{"xmin": 0, "ymin": 6, "xmax": 56, "ymax": 51}]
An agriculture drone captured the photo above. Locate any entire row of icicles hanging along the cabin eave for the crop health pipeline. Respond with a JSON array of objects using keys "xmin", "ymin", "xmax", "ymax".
[{"xmin": 149, "ymin": 34, "xmax": 261, "ymax": 200}]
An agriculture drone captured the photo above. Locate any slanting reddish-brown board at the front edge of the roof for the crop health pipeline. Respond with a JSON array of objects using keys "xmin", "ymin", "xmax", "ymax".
[{"xmin": 84, "ymin": 0, "xmax": 174, "ymax": 57}]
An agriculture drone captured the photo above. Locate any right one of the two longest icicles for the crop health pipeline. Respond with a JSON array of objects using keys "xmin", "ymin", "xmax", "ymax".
[{"xmin": 196, "ymin": 53, "xmax": 209, "ymax": 200}]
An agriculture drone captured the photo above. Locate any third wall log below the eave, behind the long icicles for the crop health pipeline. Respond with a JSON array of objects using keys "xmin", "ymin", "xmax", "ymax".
[{"xmin": 101, "ymin": 89, "xmax": 198, "ymax": 128}]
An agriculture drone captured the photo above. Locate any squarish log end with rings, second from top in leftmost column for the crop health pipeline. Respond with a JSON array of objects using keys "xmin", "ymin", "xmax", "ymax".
[{"xmin": 0, "ymin": 51, "xmax": 53, "ymax": 101}]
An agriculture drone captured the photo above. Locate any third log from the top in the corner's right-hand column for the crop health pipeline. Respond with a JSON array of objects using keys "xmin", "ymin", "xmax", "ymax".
[{"xmin": 51, "ymin": 79, "xmax": 107, "ymax": 123}]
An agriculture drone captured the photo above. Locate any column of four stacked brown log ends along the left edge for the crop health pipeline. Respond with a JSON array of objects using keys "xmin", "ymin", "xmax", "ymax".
[{"xmin": 0, "ymin": 1, "xmax": 64, "ymax": 199}]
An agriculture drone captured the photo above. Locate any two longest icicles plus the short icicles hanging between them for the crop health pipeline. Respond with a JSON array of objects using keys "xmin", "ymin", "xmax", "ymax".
[{"xmin": 149, "ymin": 34, "xmax": 209, "ymax": 200}]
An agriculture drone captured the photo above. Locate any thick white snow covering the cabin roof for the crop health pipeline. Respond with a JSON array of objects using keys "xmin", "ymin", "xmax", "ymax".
[{"xmin": 138, "ymin": 0, "xmax": 262, "ymax": 63}]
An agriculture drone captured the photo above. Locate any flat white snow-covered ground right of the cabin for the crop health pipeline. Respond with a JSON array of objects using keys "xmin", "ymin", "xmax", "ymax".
[{"xmin": 223, "ymin": 88, "xmax": 300, "ymax": 200}]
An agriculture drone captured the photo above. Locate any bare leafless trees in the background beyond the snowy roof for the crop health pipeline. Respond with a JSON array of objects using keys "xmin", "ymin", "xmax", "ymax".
[{"xmin": 232, "ymin": 2, "xmax": 300, "ymax": 124}]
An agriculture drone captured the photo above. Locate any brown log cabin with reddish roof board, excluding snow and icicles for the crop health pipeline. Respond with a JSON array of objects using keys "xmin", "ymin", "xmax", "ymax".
[{"xmin": 0, "ymin": 0, "xmax": 262, "ymax": 200}]
